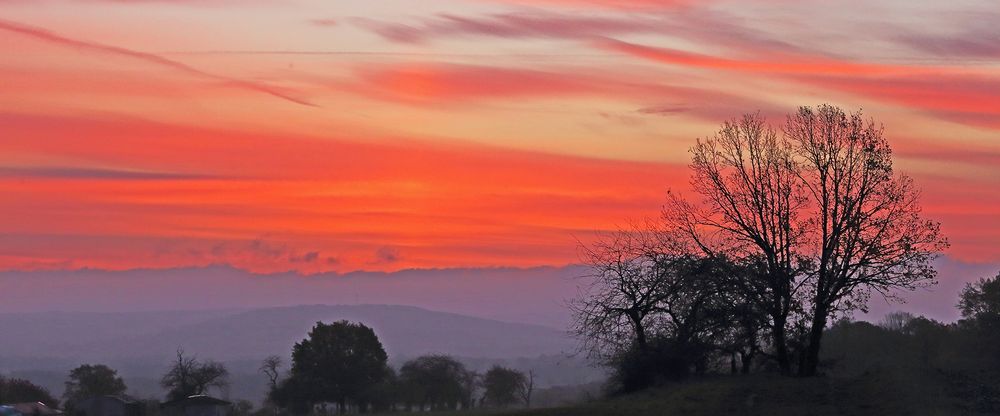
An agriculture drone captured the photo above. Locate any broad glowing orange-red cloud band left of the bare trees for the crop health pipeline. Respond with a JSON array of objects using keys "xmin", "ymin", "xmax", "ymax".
[{"xmin": 0, "ymin": 110, "xmax": 683, "ymax": 272}]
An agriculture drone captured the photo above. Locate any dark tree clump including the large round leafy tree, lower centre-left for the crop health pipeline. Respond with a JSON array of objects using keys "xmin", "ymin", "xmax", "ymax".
[{"xmin": 261, "ymin": 321, "xmax": 534, "ymax": 414}]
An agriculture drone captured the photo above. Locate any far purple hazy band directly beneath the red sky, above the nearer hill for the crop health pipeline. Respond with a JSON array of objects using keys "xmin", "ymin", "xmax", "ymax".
[{"xmin": 0, "ymin": 265, "xmax": 584, "ymax": 329}]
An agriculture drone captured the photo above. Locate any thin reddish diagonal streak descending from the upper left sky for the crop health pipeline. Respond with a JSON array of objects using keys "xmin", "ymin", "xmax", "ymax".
[{"xmin": 0, "ymin": 20, "xmax": 318, "ymax": 107}]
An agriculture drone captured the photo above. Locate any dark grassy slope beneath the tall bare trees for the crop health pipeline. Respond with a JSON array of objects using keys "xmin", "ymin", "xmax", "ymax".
[{"xmin": 517, "ymin": 372, "xmax": 987, "ymax": 416}]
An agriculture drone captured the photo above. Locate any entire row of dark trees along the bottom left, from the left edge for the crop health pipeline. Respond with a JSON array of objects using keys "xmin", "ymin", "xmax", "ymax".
[{"xmin": 0, "ymin": 321, "xmax": 535, "ymax": 416}]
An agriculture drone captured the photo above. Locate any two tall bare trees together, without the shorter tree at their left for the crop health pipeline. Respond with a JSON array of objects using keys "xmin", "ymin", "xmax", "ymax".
[{"xmin": 665, "ymin": 105, "xmax": 947, "ymax": 375}]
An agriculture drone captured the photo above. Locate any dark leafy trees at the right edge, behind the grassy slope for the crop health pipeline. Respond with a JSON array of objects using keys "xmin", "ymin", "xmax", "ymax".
[{"xmin": 823, "ymin": 273, "xmax": 1000, "ymax": 414}]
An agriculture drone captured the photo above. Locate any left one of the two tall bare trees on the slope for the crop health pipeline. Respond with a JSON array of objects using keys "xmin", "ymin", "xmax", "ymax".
[{"xmin": 664, "ymin": 114, "xmax": 806, "ymax": 373}]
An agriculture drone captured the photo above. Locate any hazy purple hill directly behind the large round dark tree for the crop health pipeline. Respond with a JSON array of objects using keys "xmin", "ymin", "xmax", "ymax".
[{"xmin": 0, "ymin": 305, "xmax": 575, "ymax": 369}]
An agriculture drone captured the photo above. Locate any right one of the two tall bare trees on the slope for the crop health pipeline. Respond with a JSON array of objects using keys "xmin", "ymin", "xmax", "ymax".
[{"xmin": 784, "ymin": 105, "xmax": 947, "ymax": 376}]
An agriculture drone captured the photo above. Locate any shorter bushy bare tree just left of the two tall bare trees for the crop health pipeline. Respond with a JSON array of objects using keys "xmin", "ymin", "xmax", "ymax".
[{"xmin": 571, "ymin": 223, "xmax": 744, "ymax": 392}]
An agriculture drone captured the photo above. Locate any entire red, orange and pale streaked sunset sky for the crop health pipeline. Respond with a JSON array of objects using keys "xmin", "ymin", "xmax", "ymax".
[{"xmin": 0, "ymin": 0, "xmax": 1000, "ymax": 316}]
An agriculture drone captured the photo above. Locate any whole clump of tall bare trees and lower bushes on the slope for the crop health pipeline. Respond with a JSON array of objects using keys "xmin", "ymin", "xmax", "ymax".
[{"xmin": 571, "ymin": 105, "xmax": 948, "ymax": 391}]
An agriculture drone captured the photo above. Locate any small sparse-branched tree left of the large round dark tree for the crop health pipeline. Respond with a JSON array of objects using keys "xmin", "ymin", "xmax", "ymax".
[{"xmin": 160, "ymin": 349, "xmax": 229, "ymax": 400}]
